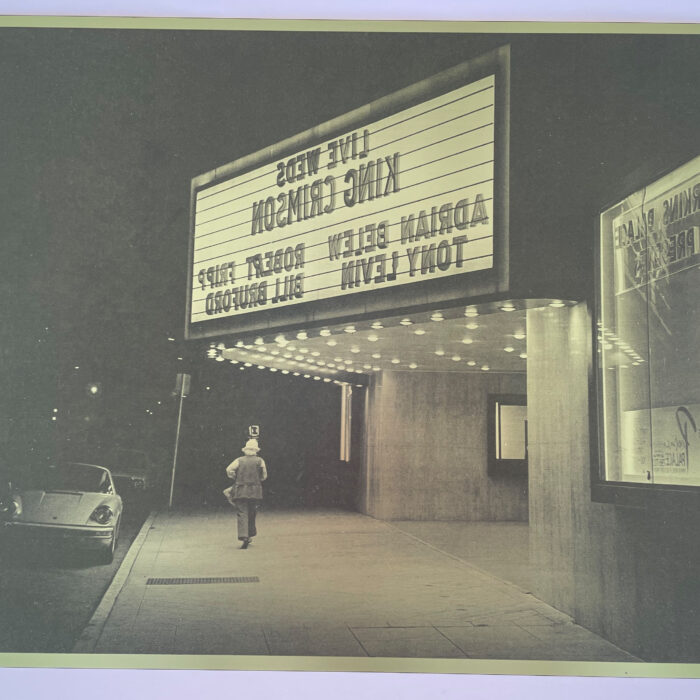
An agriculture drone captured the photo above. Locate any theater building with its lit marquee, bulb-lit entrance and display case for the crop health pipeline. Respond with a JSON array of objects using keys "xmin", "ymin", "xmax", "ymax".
[{"xmin": 186, "ymin": 36, "xmax": 700, "ymax": 661}]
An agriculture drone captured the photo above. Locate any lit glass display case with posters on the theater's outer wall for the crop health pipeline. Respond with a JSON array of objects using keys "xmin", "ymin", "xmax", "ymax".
[{"xmin": 594, "ymin": 157, "xmax": 700, "ymax": 500}]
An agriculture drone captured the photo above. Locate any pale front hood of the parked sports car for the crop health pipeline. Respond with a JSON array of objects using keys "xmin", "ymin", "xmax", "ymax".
[{"xmin": 20, "ymin": 490, "xmax": 121, "ymax": 525}]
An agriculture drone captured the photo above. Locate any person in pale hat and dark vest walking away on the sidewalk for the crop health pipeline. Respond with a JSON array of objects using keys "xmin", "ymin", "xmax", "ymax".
[{"xmin": 226, "ymin": 439, "xmax": 267, "ymax": 549}]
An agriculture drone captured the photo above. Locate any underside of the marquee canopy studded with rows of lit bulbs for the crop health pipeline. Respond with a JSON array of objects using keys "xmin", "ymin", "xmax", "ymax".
[{"xmin": 208, "ymin": 300, "xmax": 568, "ymax": 381}]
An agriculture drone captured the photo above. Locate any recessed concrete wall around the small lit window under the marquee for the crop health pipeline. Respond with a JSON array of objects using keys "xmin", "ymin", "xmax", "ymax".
[{"xmin": 360, "ymin": 372, "xmax": 527, "ymax": 520}]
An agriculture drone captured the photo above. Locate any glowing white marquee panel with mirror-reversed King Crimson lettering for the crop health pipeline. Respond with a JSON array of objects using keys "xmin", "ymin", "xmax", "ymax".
[{"xmin": 188, "ymin": 47, "xmax": 508, "ymax": 338}]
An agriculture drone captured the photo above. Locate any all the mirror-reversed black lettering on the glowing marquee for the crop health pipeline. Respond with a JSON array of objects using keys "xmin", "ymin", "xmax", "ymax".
[{"xmin": 197, "ymin": 129, "xmax": 491, "ymax": 316}]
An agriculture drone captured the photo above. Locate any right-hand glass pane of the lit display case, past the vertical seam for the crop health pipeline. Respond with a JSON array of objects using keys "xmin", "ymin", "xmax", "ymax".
[{"xmin": 648, "ymin": 158, "xmax": 700, "ymax": 486}]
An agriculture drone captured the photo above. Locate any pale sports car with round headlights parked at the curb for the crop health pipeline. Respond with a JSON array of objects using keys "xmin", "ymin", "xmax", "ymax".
[{"xmin": 0, "ymin": 462, "xmax": 122, "ymax": 563}]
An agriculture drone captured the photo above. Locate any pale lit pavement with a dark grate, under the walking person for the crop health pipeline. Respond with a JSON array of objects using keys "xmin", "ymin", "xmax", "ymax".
[{"xmin": 75, "ymin": 510, "xmax": 638, "ymax": 662}]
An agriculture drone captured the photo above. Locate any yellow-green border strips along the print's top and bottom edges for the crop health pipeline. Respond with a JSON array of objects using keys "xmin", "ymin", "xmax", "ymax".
[{"xmin": 0, "ymin": 15, "xmax": 700, "ymax": 678}]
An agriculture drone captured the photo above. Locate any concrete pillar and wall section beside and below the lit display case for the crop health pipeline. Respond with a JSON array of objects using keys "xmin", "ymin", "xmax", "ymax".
[{"xmin": 527, "ymin": 305, "xmax": 700, "ymax": 662}]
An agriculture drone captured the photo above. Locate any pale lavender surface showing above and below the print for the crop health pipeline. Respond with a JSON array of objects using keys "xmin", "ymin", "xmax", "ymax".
[{"xmin": 0, "ymin": 0, "xmax": 700, "ymax": 700}]
